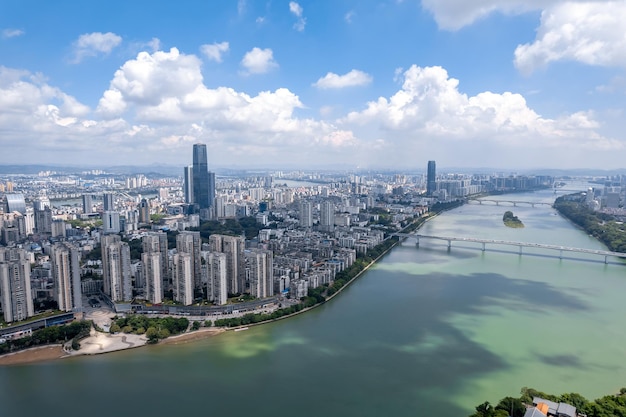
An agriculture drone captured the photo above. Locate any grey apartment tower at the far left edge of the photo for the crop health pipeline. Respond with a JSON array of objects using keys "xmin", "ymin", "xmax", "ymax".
[{"xmin": 0, "ymin": 248, "xmax": 35, "ymax": 323}]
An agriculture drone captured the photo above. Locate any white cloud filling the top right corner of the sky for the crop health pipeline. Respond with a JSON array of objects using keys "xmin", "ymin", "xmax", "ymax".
[{"xmin": 515, "ymin": 1, "xmax": 626, "ymax": 74}]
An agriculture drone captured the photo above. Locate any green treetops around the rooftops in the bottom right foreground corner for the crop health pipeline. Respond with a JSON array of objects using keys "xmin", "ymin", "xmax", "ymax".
[{"xmin": 471, "ymin": 387, "xmax": 626, "ymax": 417}]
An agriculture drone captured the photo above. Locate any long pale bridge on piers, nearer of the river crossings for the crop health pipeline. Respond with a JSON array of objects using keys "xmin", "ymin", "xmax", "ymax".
[{"xmin": 394, "ymin": 233, "xmax": 626, "ymax": 263}]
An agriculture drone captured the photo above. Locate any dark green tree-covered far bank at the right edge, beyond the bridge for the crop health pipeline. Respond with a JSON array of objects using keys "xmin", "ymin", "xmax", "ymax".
[{"xmin": 554, "ymin": 196, "xmax": 626, "ymax": 253}]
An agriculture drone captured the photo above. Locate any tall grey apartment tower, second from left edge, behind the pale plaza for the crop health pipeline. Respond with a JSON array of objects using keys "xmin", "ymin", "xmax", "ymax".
[{"xmin": 50, "ymin": 242, "xmax": 83, "ymax": 311}]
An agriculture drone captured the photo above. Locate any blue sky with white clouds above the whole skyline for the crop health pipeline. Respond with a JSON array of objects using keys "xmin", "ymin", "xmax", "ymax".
[{"xmin": 0, "ymin": 0, "xmax": 626, "ymax": 170}]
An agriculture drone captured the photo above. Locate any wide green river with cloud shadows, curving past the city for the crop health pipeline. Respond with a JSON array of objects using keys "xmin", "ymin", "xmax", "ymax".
[{"xmin": 0, "ymin": 191, "xmax": 626, "ymax": 417}]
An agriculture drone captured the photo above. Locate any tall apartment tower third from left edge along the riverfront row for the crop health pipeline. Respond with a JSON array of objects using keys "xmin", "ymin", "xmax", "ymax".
[{"xmin": 100, "ymin": 235, "xmax": 133, "ymax": 301}]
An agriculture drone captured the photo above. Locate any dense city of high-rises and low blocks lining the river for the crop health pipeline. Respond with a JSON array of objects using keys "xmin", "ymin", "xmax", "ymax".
[{"xmin": 0, "ymin": 144, "xmax": 623, "ymax": 342}]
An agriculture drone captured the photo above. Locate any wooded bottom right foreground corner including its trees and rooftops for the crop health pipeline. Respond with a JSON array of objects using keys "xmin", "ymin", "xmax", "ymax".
[{"xmin": 470, "ymin": 387, "xmax": 626, "ymax": 417}]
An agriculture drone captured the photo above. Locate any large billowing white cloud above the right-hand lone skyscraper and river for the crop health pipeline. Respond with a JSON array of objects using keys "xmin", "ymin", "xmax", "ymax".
[{"xmin": 339, "ymin": 65, "xmax": 624, "ymax": 162}]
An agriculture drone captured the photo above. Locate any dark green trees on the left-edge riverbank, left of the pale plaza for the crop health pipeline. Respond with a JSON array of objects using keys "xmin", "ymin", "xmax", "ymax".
[{"xmin": 0, "ymin": 320, "xmax": 91, "ymax": 355}]
